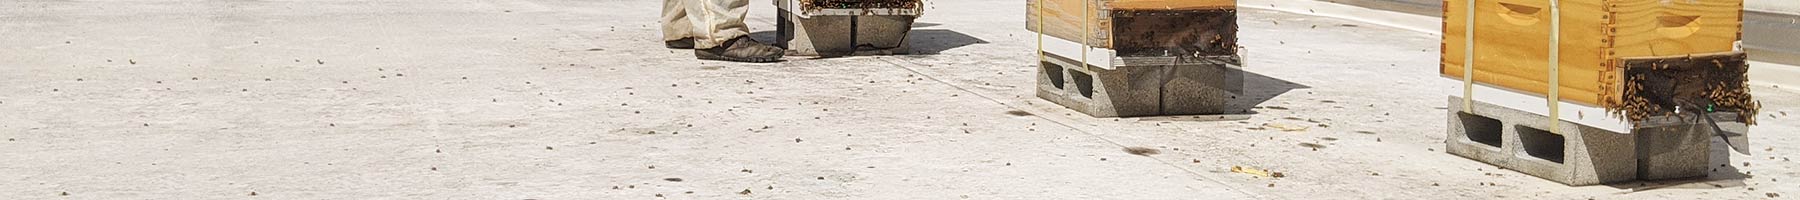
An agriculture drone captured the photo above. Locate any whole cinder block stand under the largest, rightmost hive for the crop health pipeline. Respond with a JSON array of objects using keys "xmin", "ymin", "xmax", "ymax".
[{"xmin": 1444, "ymin": 97, "xmax": 1748, "ymax": 186}]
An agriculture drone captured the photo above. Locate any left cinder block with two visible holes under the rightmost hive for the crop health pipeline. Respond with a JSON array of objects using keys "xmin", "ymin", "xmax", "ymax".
[{"xmin": 1445, "ymin": 97, "xmax": 1638, "ymax": 186}]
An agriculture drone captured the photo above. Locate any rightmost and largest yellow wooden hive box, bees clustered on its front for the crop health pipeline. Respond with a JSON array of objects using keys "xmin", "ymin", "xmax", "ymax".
[{"xmin": 1440, "ymin": 0, "xmax": 1755, "ymax": 121}]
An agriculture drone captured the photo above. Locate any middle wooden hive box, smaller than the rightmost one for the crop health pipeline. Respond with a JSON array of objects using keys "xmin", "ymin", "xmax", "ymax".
[{"xmin": 1026, "ymin": 0, "xmax": 1237, "ymax": 63}]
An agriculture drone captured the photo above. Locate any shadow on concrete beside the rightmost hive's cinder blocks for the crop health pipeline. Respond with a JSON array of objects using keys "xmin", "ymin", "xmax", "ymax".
[{"xmin": 1607, "ymin": 137, "xmax": 1750, "ymax": 193}]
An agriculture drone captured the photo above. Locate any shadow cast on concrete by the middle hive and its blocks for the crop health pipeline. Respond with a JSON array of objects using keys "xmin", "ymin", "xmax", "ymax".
[{"xmin": 1138, "ymin": 70, "xmax": 1312, "ymax": 121}]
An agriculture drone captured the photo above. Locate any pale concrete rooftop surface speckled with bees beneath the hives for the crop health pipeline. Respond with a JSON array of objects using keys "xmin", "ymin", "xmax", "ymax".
[{"xmin": 0, "ymin": 0, "xmax": 1800, "ymax": 200}]
